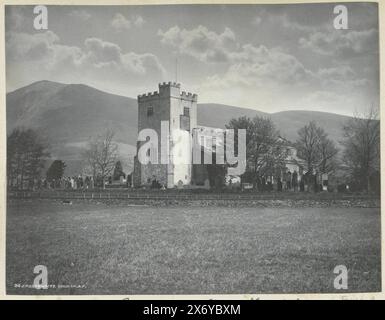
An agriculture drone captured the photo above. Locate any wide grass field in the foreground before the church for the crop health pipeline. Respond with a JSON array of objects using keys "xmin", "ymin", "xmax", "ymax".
[{"xmin": 6, "ymin": 200, "xmax": 381, "ymax": 294}]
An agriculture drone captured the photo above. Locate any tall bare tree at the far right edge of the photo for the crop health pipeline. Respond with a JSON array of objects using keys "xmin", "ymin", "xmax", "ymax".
[{"xmin": 343, "ymin": 106, "xmax": 380, "ymax": 193}]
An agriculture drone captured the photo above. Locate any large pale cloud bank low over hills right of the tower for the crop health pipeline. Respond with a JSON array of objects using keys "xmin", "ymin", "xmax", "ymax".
[{"xmin": 199, "ymin": 34, "xmax": 371, "ymax": 111}]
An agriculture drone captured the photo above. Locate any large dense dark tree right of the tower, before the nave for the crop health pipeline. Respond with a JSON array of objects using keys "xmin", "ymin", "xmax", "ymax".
[{"xmin": 226, "ymin": 116, "xmax": 288, "ymax": 187}]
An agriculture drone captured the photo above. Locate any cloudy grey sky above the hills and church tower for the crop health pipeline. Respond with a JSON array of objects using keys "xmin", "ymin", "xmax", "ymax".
[{"xmin": 6, "ymin": 3, "xmax": 379, "ymax": 115}]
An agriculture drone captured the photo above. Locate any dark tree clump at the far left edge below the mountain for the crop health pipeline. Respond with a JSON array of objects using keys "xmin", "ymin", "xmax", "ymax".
[{"xmin": 7, "ymin": 128, "xmax": 49, "ymax": 189}]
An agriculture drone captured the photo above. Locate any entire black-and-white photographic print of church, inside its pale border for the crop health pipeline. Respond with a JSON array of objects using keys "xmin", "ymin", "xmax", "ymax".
[{"xmin": 5, "ymin": 2, "xmax": 381, "ymax": 297}]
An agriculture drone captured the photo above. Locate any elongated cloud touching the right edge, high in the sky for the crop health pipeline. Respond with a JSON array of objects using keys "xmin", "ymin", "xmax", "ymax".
[{"xmin": 299, "ymin": 29, "xmax": 378, "ymax": 59}]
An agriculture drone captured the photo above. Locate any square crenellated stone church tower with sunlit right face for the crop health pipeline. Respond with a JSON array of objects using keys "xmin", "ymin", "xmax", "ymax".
[{"xmin": 134, "ymin": 82, "xmax": 197, "ymax": 188}]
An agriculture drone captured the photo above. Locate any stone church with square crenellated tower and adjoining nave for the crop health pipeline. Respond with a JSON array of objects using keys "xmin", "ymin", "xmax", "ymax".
[{"xmin": 133, "ymin": 82, "xmax": 299, "ymax": 188}]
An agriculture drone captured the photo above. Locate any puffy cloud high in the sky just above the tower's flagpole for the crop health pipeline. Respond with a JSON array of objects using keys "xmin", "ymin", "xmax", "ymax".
[{"xmin": 158, "ymin": 25, "xmax": 239, "ymax": 62}]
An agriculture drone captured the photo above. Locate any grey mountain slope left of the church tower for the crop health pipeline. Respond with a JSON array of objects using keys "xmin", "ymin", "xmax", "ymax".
[{"xmin": 7, "ymin": 81, "xmax": 137, "ymax": 174}]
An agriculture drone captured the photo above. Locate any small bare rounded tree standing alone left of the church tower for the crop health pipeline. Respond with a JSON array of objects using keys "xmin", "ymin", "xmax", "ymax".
[{"xmin": 84, "ymin": 129, "xmax": 118, "ymax": 188}]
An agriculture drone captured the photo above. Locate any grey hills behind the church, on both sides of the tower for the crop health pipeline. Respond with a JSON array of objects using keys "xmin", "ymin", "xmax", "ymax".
[{"xmin": 7, "ymin": 81, "xmax": 348, "ymax": 174}]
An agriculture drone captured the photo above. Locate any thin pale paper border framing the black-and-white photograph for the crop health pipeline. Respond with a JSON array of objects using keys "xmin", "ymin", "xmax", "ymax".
[{"xmin": 0, "ymin": 0, "xmax": 385, "ymax": 300}]
